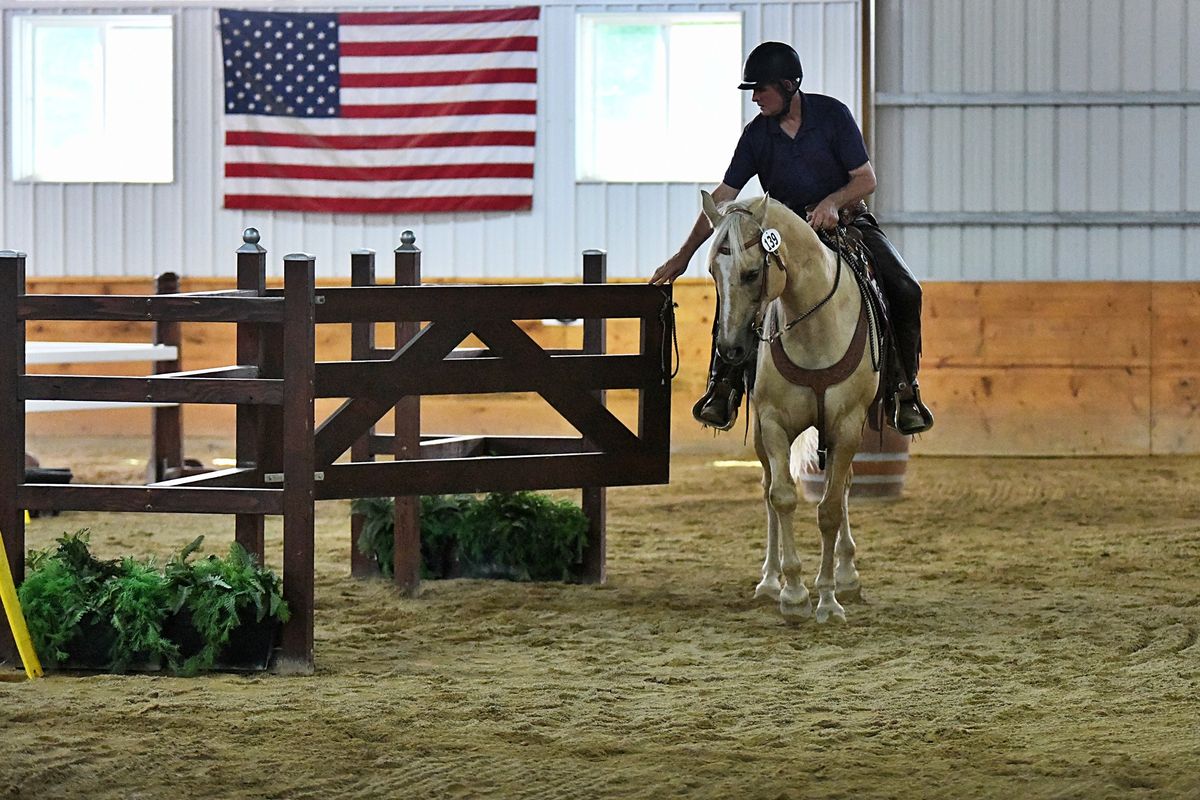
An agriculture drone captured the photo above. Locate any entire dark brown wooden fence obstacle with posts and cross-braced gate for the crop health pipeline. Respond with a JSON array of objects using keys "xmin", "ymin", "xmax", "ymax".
[{"xmin": 0, "ymin": 229, "xmax": 672, "ymax": 673}]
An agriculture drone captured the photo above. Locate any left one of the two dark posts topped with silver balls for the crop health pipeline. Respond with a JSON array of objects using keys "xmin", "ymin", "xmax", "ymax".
[{"xmin": 234, "ymin": 228, "xmax": 266, "ymax": 564}]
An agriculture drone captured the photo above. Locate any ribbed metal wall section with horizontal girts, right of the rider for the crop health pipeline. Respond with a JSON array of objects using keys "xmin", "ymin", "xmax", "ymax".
[{"xmin": 874, "ymin": 0, "xmax": 1200, "ymax": 281}]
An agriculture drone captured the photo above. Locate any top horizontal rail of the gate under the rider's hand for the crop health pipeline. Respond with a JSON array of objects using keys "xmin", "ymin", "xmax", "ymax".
[{"xmin": 317, "ymin": 283, "xmax": 666, "ymax": 323}]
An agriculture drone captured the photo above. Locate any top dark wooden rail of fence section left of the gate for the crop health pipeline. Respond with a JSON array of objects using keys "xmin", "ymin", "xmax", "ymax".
[{"xmin": 17, "ymin": 295, "xmax": 283, "ymax": 323}]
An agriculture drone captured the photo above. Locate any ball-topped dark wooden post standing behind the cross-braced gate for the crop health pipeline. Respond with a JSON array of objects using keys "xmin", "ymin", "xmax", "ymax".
[{"xmin": 392, "ymin": 230, "xmax": 421, "ymax": 595}]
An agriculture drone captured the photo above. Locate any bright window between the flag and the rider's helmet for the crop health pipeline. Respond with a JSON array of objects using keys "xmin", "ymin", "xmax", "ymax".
[{"xmin": 575, "ymin": 13, "xmax": 742, "ymax": 184}]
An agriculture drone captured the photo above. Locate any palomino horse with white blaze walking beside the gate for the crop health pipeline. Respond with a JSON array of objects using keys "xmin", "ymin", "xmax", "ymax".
[{"xmin": 702, "ymin": 192, "xmax": 878, "ymax": 622}]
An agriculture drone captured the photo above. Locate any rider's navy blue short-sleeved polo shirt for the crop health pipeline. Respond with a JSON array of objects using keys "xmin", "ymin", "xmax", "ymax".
[{"xmin": 722, "ymin": 92, "xmax": 868, "ymax": 215}]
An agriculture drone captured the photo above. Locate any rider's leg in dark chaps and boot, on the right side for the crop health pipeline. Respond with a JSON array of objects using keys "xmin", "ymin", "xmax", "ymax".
[{"xmin": 853, "ymin": 213, "xmax": 934, "ymax": 434}]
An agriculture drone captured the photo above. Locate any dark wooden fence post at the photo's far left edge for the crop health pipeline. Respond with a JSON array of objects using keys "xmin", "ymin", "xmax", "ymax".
[{"xmin": 0, "ymin": 249, "xmax": 25, "ymax": 663}]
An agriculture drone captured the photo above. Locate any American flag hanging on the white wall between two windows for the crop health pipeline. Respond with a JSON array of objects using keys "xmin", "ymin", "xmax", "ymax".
[{"xmin": 218, "ymin": 7, "xmax": 540, "ymax": 213}]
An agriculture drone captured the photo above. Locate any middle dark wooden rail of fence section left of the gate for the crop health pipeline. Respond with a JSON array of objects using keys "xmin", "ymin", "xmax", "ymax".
[{"xmin": 18, "ymin": 375, "xmax": 283, "ymax": 405}]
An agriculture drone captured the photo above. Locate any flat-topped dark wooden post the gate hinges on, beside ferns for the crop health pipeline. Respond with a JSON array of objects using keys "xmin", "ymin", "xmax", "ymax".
[{"xmin": 277, "ymin": 253, "xmax": 317, "ymax": 674}]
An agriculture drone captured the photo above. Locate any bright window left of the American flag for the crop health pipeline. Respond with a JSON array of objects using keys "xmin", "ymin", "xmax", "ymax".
[{"xmin": 12, "ymin": 14, "xmax": 174, "ymax": 184}]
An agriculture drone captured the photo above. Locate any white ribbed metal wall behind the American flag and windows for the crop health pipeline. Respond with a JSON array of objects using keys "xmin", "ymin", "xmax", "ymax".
[{"xmin": 0, "ymin": 0, "xmax": 862, "ymax": 278}]
